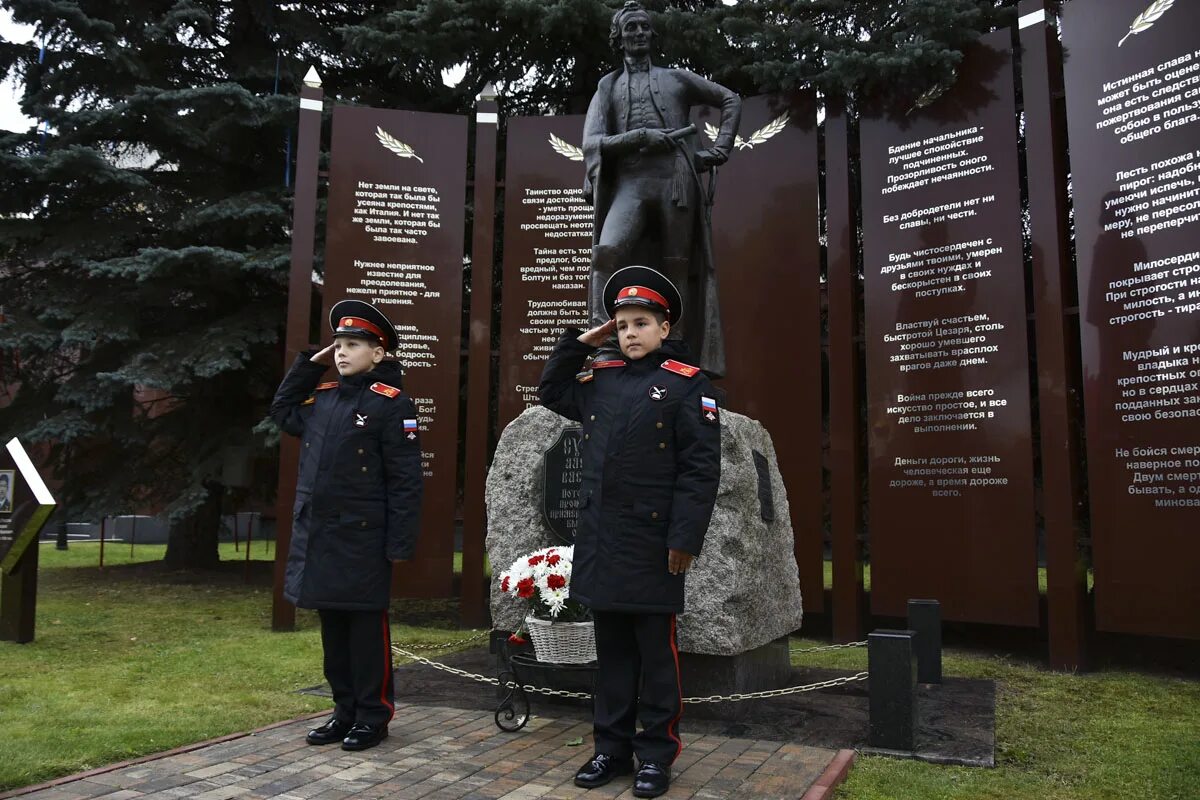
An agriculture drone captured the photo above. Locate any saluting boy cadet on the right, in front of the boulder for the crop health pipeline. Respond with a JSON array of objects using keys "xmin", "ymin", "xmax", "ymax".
[{"xmin": 540, "ymin": 266, "xmax": 721, "ymax": 798}]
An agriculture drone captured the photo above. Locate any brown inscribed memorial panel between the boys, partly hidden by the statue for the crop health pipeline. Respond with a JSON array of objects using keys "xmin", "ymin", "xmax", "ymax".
[{"xmin": 498, "ymin": 115, "xmax": 593, "ymax": 429}]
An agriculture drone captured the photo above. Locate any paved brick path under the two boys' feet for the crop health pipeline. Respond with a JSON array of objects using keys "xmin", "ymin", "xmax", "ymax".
[{"xmin": 11, "ymin": 705, "xmax": 848, "ymax": 800}]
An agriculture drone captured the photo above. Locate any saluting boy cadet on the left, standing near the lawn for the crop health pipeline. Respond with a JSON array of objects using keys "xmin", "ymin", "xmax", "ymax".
[{"xmin": 271, "ymin": 300, "xmax": 421, "ymax": 750}]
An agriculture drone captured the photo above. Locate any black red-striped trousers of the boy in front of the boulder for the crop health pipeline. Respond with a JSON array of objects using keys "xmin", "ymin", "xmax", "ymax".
[{"xmin": 593, "ymin": 610, "xmax": 683, "ymax": 765}]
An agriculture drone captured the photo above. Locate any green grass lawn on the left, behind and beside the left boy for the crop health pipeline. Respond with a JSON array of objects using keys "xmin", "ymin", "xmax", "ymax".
[{"xmin": 0, "ymin": 551, "xmax": 487, "ymax": 790}]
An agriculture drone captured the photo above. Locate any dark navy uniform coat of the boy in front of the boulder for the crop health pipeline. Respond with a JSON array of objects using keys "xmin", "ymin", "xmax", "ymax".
[{"xmin": 540, "ymin": 330, "xmax": 721, "ymax": 613}]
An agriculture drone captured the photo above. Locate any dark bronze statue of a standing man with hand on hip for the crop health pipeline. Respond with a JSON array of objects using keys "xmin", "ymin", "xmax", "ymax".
[{"xmin": 583, "ymin": 0, "xmax": 742, "ymax": 377}]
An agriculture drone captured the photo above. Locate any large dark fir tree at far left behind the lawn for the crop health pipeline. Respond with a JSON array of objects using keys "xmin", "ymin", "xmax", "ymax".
[{"xmin": 0, "ymin": 0, "xmax": 321, "ymax": 565}]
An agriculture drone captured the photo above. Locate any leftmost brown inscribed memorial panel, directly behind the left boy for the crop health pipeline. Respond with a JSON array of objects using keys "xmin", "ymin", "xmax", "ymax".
[{"xmin": 322, "ymin": 107, "xmax": 467, "ymax": 596}]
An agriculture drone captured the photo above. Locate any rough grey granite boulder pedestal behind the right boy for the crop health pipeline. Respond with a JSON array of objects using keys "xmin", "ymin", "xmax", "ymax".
[{"xmin": 486, "ymin": 407, "xmax": 804, "ymax": 696}]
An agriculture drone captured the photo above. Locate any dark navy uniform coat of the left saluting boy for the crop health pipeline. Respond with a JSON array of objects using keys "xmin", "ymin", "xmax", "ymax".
[{"xmin": 270, "ymin": 351, "xmax": 421, "ymax": 610}]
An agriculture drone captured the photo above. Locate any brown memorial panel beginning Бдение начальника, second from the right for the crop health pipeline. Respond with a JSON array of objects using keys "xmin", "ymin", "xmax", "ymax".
[{"xmin": 860, "ymin": 30, "xmax": 1038, "ymax": 626}]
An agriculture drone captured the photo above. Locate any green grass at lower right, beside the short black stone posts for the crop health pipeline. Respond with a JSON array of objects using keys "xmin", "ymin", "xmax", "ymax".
[{"xmin": 792, "ymin": 639, "xmax": 1200, "ymax": 800}]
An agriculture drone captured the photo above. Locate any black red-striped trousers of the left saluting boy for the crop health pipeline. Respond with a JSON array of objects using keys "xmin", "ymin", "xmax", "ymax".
[{"xmin": 318, "ymin": 608, "xmax": 396, "ymax": 724}]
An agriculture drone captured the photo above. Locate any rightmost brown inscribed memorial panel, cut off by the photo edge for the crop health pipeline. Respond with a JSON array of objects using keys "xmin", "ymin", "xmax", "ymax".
[{"xmin": 1062, "ymin": 0, "xmax": 1200, "ymax": 638}]
